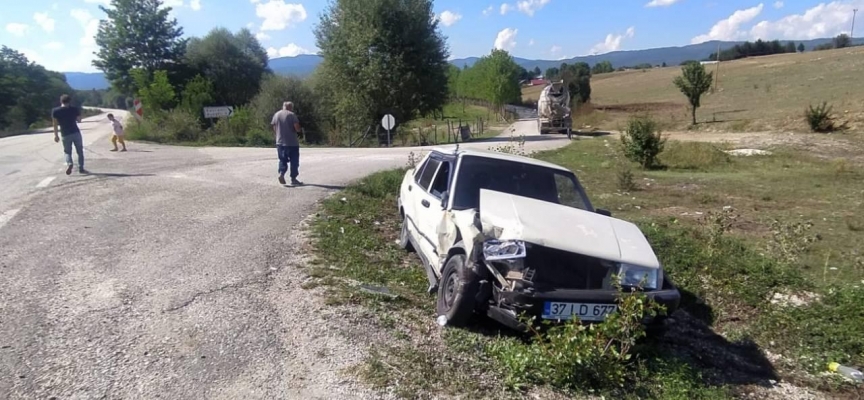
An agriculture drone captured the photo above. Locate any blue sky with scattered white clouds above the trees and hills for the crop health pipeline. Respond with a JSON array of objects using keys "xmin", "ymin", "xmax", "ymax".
[{"xmin": 0, "ymin": 0, "xmax": 864, "ymax": 72}]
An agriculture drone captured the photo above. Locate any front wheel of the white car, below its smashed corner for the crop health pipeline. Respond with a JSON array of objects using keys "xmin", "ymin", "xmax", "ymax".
[{"xmin": 437, "ymin": 254, "xmax": 479, "ymax": 327}]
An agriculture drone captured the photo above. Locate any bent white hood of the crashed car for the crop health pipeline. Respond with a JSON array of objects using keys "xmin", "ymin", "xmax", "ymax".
[{"xmin": 480, "ymin": 189, "xmax": 660, "ymax": 268}]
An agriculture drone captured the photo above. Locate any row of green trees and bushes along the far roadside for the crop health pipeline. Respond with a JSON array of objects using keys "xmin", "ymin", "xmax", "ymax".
[{"xmin": 82, "ymin": 0, "xmax": 536, "ymax": 145}]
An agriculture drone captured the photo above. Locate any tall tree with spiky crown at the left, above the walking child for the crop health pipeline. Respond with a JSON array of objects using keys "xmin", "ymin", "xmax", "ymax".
[{"xmin": 93, "ymin": 0, "xmax": 186, "ymax": 94}]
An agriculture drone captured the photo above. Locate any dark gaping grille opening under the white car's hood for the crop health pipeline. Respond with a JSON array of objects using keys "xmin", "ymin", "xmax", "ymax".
[{"xmin": 525, "ymin": 245, "xmax": 613, "ymax": 291}]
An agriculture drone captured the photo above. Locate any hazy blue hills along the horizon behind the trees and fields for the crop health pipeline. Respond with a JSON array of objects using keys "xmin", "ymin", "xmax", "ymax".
[{"xmin": 65, "ymin": 38, "xmax": 864, "ymax": 90}]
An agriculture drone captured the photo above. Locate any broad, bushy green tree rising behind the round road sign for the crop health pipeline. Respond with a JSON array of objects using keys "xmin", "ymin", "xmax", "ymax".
[{"xmin": 315, "ymin": 0, "xmax": 449, "ymax": 136}]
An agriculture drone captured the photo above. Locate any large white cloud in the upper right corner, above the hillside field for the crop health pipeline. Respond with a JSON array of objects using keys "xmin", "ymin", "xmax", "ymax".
[{"xmin": 746, "ymin": 0, "xmax": 864, "ymax": 40}]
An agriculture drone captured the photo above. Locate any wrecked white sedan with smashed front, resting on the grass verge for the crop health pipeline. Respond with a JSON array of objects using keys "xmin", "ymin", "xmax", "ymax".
[{"xmin": 397, "ymin": 148, "xmax": 681, "ymax": 330}]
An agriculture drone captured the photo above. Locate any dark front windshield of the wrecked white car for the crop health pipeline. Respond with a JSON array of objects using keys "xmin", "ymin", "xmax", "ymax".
[{"xmin": 453, "ymin": 156, "xmax": 591, "ymax": 211}]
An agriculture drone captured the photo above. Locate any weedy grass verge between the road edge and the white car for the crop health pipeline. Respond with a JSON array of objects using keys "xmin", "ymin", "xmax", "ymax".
[{"xmin": 308, "ymin": 161, "xmax": 733, "ymax": 399}]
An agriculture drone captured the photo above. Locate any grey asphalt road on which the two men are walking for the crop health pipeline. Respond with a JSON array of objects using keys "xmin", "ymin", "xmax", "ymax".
[{"xmin": 0, "ymin": 111, "xmax": 567, "ymax": 399}]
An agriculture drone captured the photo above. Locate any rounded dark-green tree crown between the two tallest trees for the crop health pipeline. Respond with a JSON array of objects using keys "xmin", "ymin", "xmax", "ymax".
[{"xmin": 184, "ymin": 28, "xmax": 270, "ymax": 106}]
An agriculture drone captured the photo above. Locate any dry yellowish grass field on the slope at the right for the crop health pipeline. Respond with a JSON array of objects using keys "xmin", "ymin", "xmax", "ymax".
[{"xmin": 523, "ymin": 47, "xmax": 864, "ymax": 132}]
